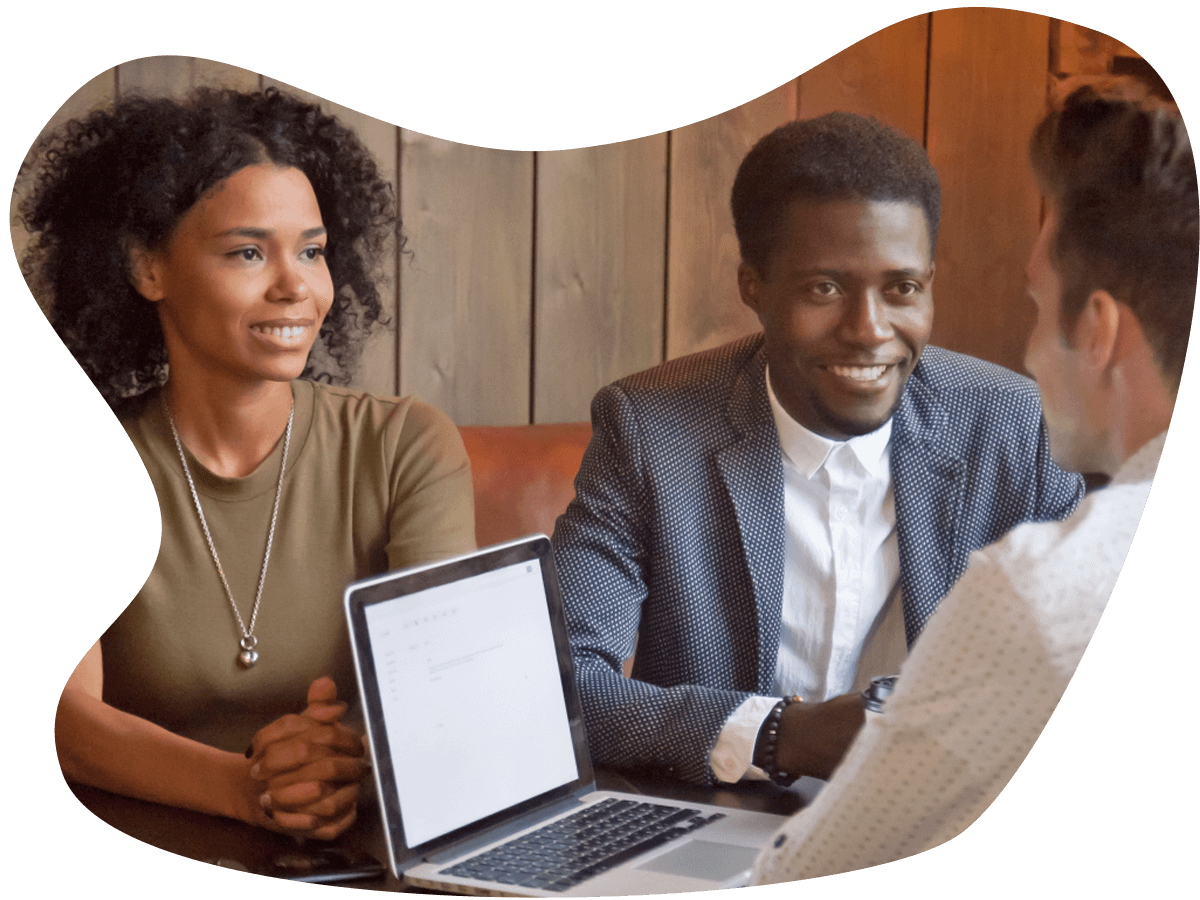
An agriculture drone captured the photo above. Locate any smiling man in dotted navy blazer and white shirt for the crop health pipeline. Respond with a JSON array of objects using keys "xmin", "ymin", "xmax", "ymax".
[{"xmin": 554, "ymin": 113, "xmax": 1082, "ymax": 784}]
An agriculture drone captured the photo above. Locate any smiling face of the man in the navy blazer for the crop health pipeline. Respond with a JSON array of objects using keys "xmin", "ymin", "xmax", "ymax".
[{"xmin": 738, "ymin": 200, "xmax": 934, "ymax": 440}]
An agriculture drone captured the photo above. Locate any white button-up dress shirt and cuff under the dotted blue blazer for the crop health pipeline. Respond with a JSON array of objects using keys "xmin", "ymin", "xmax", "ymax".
[{"xmin": 709, "ymin": 371, "xmax": 907, "ymax": 781}]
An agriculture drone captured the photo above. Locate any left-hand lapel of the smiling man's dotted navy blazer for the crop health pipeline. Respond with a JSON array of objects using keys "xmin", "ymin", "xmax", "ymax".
[{"xmin": 716, "ymin": 349, "xmax": 785, "ymax": 692}]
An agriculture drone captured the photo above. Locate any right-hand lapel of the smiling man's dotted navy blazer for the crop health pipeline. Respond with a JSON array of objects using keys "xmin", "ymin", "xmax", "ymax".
[{"xmin": 892, "ymin": 365, "xmax": 966, "ymax": 649}]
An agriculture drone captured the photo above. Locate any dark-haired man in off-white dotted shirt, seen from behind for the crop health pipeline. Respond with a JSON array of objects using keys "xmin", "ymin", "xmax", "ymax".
[{"xmin": 757, "ymin": 80, "xmax": 1200, "ymax": 883}]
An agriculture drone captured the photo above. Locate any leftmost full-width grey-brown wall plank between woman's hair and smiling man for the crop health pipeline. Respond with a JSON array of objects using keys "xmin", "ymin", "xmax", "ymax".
[{"xmin": 400, "ymin": 128, "xmax": 533, "ymax": 425}]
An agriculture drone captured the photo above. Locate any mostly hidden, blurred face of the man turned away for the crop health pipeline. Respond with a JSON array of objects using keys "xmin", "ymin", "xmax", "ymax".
[{"xmin": 1025, "ymin": 205, "xmax": 1097, "ymax": 472}]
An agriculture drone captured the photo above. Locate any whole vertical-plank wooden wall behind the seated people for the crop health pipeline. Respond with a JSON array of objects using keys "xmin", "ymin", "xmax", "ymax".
[{"xmin": 23, "ymin": 22, "xmax": 1161, "ymax": 425}]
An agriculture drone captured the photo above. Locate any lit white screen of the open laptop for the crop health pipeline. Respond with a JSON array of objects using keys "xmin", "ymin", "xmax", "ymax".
[{"xmin": 360, "ymin": 549, "xmax": 580, "ymax": 847}]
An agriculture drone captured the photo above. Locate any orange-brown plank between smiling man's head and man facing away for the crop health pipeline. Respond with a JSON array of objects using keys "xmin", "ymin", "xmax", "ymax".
[{"xmin": 929, "ymin": 7, "xmax": 1049, "ymax": 371}]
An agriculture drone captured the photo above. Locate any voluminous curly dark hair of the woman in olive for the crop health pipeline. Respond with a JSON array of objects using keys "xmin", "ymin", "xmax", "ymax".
[{"xmin": 19, "ymin": 88, "xmax": 403, "ymax": 409}]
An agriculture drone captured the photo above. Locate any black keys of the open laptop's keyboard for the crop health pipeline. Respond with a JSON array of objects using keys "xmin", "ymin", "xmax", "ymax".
[{"xmin": 443, "ymin": 799, "xmax": 724, "ymax": 890}]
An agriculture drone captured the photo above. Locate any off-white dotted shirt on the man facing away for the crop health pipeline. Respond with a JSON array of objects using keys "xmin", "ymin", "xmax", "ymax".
[{"xmin": 755, "ymin": 432, "xmax": 1166, "ymax": 884}]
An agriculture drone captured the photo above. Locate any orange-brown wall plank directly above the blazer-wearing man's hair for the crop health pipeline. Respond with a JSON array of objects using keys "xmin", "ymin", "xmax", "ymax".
[{"xmin": 797, "ymin": 13, "xmax": 929, "ymax": 145}]
